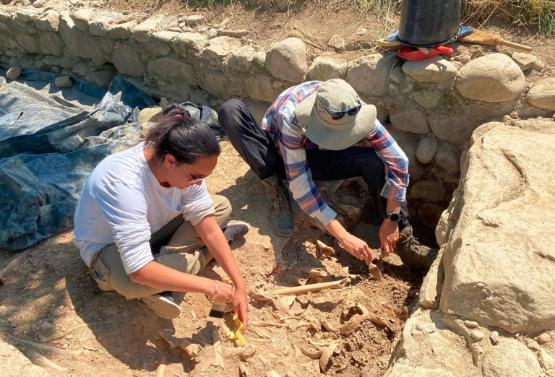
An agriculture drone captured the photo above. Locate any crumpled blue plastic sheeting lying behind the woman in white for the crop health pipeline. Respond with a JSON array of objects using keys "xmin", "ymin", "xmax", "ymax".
[{"xmin": 0, "ymin": 67, "xmax": 159, "ymax": 250}]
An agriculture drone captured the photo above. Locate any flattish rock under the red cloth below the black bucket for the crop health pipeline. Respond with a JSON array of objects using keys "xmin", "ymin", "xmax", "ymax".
[{"xmin": 403, "ymin": 55, "xmax": 457, "ymax": 82}]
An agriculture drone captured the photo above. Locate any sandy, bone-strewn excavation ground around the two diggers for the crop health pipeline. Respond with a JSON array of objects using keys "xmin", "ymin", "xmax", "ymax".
[{"xmin": 0, "ymin": 141, "xmax": 421, "ymax": 377}]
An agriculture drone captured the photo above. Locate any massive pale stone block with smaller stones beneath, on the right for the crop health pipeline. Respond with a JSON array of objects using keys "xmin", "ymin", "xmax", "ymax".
[{"xmin": 387, "ymin": 118, "xmax": 555, "ymax": 377}]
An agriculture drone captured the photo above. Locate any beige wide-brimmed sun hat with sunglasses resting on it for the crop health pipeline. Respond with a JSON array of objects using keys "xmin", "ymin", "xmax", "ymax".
[{"xmin": 295, "ymin": 79, "xmax": 376, "ymax": 150}]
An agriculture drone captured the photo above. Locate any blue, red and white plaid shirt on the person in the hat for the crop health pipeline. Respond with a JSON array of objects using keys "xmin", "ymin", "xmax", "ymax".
[{"xmin": 262, "ymin": 81, "xmax": 409, "ymax": 226}]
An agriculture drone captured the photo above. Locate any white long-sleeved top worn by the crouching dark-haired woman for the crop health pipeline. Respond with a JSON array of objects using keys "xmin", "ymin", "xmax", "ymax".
[{"xmin": 74, "ymin": 143, "xmax": 214, "ymax": 274}]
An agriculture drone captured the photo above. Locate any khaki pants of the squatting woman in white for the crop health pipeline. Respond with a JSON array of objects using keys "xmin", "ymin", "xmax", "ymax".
[{"xmin": 90, "ymin": 195, "xmax": 231, "ymax": 300}]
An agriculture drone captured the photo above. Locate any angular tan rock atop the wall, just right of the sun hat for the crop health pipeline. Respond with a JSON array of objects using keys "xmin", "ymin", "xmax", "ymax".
[{"xmin": 346, "ymin": 54, "xmax": 396, "ymax": 97}]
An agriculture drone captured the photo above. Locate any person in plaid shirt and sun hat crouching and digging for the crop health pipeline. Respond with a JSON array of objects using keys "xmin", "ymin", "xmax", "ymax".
[{"xmin": 218, "ymin": 79, "xmax": 437, "ymax": 268}]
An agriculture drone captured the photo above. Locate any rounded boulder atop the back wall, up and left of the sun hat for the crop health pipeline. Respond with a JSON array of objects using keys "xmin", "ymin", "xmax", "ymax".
[{"xmin": 265, "ymin": 38, "xmax": 308, "ymax": 82}]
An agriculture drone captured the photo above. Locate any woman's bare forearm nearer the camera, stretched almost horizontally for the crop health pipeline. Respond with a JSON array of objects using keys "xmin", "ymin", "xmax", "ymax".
[{"xmin": 130, "ymin": 261, "xmax": 214, "ymax": 295}]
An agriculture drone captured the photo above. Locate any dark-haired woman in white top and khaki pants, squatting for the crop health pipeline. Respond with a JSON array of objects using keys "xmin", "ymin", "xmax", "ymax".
[{"xmin": 74, "ymin": 106, "xmax": 248, "ymax": 326}]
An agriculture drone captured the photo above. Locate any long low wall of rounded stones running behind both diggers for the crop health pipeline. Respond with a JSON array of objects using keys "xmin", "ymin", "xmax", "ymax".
[{"xmin": 0, "ymin": 6, "xmax": 555, "ymax": 226}]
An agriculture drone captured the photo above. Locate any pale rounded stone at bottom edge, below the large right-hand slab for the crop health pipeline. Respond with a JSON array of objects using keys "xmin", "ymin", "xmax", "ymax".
[{"xmin": 482, "ymin": 338, "xmax": 544, "ymax": 377}]
